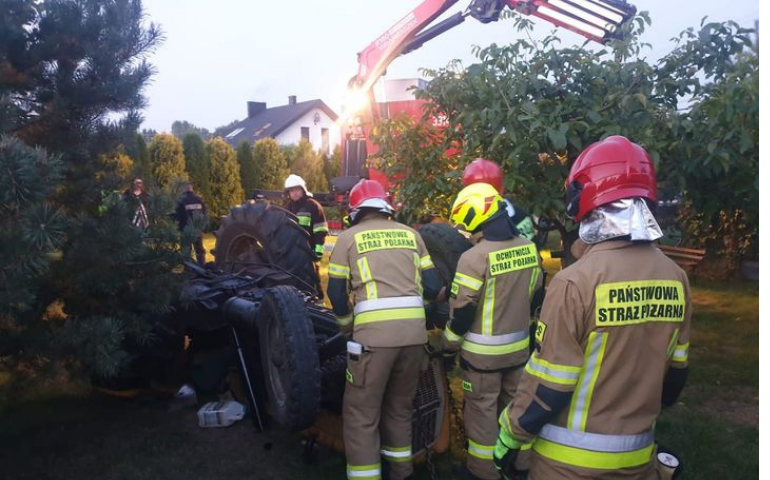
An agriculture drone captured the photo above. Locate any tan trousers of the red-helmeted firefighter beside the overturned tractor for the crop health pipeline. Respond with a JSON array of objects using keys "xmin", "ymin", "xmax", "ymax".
[{"xmin": 342, "ymin": 345, "xmax": 426, "ymax": 480}]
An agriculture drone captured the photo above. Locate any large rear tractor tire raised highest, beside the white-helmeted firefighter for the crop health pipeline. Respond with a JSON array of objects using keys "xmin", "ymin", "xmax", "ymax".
[{"xmin": 213, "ymin": 201, "xmax": 320, "ymax": 293}]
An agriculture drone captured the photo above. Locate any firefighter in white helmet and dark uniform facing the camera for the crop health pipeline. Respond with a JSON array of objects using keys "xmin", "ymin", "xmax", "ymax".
[{"xmin": 283, "ymin": 174, "xmax": 329, "ymax": 299}]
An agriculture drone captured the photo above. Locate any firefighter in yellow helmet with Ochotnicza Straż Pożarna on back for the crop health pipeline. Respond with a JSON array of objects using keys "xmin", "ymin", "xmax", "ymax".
[{"xmin": 444, "ymin": 183, "xmax": 542, "ymax": 480}]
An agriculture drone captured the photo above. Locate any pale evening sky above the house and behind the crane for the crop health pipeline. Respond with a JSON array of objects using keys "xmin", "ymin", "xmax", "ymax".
[{"xmin": 136, "ymin": 0, "xmax": 759, "ymax": 131}]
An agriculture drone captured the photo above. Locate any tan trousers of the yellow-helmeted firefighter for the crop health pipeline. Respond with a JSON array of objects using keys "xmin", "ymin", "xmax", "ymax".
[{"xmin": 463, "ymin": 367, "xmax": 524, "ymax": 480}]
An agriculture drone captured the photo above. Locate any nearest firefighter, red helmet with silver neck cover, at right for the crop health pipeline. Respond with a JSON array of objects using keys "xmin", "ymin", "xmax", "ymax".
[{"xmin": 494, "ymin": 136, "xmax": 691, "ymax": 480}]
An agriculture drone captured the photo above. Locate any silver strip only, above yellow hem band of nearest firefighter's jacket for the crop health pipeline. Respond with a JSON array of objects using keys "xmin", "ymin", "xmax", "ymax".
[{"xmin": 538, "ymin": 424, "xmax": 655, "ymax": 453}]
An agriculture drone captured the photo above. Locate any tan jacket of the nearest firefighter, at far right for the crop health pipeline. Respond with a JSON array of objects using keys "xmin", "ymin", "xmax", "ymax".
[{"xmin": 500, "ymin": 240, "xmax": 691, "ymax": 478}]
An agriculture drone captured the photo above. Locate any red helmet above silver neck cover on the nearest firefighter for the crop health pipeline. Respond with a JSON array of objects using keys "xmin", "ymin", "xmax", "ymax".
[{"xmin": 566, "ymin": 136, "xmax": 658, "ymax": 221}]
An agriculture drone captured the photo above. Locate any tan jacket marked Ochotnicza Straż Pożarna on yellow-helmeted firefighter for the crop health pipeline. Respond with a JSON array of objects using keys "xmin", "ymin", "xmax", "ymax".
[{"xmin": 444, "ymin": 237, "xmax": 543, "ymax": 371}]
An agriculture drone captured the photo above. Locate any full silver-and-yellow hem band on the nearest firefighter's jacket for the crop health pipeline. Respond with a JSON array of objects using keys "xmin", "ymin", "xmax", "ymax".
[{"xmin": 534, "ymin": 425, "xmax": 655, "ymax": 470}]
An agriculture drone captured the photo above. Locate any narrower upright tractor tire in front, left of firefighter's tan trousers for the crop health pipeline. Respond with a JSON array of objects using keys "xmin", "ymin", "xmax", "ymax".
[{"xmin": 256, "ymin": 286, "xmax": 321, "ymax": 431}]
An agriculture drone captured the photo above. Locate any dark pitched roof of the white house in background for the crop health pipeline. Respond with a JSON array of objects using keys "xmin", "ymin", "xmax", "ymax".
[{"xmin": 220, "ymin": 99, "xmax": 337, "ymax": 147}]
